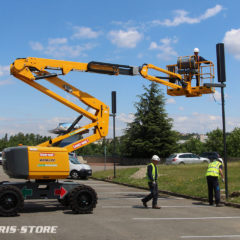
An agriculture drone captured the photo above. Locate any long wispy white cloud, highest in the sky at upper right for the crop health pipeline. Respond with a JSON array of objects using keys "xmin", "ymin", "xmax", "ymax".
[{"xmin": 152, "ymin": 5, "xmax": 223, "ymax": 27}]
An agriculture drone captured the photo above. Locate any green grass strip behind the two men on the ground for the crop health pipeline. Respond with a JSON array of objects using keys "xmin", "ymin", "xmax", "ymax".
[{"xmin": 93, "ymin": 162, "xmax": 240, "ymax": 203}]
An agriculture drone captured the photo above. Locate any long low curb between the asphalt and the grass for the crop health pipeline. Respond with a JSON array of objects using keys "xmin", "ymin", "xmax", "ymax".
[{"xmin": 91, "ymin": 177, "xmax": 240, "ymax": 208}]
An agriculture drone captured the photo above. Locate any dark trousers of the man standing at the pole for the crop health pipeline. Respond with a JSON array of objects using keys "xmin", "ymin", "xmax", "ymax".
[{"xmin": 207, "ymin": 176, "xmax": 220, "ymax": 204}]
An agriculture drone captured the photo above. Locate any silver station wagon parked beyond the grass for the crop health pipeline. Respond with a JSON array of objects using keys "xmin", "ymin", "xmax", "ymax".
[{"xmin": 166, "ymin": 153, "xmax": 210, "ymax": 165}]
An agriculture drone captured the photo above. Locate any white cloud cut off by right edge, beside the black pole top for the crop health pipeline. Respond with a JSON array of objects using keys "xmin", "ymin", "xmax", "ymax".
[{"xmin": 223, "ymin": 28, "xmax": 240, "ymax": 60}]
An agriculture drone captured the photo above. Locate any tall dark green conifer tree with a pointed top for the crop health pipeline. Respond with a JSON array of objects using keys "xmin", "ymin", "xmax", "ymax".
[{"xmin": 122, "ymin": 83, "xmax": 178, "ymax": 158}]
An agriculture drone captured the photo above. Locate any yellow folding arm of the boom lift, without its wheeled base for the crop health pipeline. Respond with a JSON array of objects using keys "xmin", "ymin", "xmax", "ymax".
[{"xmin": 11, "ymin": 57, "xmax": 214, "ymax": 152}]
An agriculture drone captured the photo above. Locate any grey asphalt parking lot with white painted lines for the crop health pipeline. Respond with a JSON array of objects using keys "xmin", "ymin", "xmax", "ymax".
[{"xmin": 0, "ymin": 169, "xmax": 240, "ymax": 240}]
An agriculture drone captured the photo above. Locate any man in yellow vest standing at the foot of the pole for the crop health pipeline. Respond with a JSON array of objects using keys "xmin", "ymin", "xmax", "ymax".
[{"xmin": 206, "ymin": 158, "xmax": 224, "ymax": 207}]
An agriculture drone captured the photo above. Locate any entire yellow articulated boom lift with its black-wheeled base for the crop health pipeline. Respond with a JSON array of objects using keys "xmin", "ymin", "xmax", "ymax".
[{"xmin": 0, "ymin": 56, "xmax": 214, "ymax": 216}]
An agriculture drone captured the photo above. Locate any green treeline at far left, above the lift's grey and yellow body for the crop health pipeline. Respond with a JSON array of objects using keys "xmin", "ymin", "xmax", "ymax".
[{"xmin": 0, "ymin": 132, "xmax": 50, "ymax": 151}]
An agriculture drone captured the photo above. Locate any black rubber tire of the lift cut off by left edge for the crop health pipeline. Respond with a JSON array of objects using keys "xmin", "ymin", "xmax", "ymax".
[{"xmin": 0, "ymin": 185, "xmax": 24, "ymax": 217}]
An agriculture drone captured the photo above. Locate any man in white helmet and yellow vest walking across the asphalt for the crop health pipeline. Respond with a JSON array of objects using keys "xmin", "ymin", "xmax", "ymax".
[{"xmin": 142, "ymin": 155, "xmax": 161, "ymax": 209}]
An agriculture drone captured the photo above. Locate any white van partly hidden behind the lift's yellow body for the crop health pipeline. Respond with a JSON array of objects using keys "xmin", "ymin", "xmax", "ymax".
[{"xmin": 69, "ymin": 153, "xmax": 92, "ymax": 179}]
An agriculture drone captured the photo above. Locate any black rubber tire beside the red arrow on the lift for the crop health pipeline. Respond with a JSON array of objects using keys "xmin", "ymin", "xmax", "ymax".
[{"xmin": 69, "ymin": 185, "xmax": 97, "ymax": 214}]
